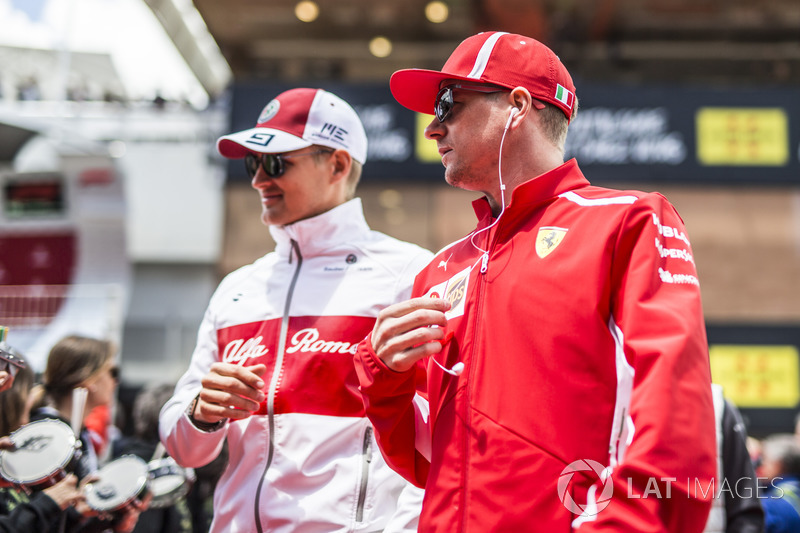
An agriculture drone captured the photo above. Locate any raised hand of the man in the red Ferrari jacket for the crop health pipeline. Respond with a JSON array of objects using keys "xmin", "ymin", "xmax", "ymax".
[{"xmin": 372, "ymin": 298, "xmax": 450, "ymax": 372}]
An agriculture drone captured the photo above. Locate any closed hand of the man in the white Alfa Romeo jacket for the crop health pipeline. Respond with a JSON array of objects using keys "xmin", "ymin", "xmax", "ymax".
[{"xmin": 192, "ymin": 363, "xmax": 267, "ymax": 424}]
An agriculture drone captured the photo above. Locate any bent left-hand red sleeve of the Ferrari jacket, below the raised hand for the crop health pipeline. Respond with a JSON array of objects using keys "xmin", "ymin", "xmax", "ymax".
[{"xmin": 354, "ymin": 334, "xmax": 430, "ymax": 487}]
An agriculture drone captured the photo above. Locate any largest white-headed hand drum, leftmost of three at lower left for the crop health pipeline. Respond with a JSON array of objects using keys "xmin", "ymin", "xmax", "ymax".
[{"xmin": 0, "ymin": 419, "xmax": 81, "ymax": 490}]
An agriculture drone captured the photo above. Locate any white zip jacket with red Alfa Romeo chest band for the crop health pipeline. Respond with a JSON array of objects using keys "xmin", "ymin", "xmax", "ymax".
[{"xmin": 160, "ymin": 199, "xmax": 432, "ymax": 533}]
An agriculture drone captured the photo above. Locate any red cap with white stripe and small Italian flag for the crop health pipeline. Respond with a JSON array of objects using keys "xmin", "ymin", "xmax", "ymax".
[{"xmin": 389, "ymin": 31, "xmax": 575, "ymax": 120}]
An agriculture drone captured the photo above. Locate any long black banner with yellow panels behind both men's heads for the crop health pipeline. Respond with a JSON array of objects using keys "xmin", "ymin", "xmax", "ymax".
[{"xmin": 229, "ymin": 82, "xmax": 800, "ymax": 184}]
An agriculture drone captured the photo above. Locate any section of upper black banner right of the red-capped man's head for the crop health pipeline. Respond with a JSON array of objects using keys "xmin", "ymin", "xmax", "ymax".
[{"xmin": 566, "ymin": 86, "xmax": 800, "ymax": 184}]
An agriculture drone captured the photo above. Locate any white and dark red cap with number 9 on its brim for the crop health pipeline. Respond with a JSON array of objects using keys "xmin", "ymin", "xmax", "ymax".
[{"xmin": 217, "ymin": 88, "xmax": 367, "ymax": 164}]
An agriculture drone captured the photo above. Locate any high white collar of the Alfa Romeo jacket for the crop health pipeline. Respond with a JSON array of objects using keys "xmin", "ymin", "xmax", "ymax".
[{"xmin": 269, "ymin": 198, "xmax": 370, "ymax": 257}]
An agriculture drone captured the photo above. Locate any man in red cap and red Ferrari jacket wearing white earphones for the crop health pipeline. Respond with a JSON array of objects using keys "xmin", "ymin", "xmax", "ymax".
[{"xmin": 355, "ymin": 32, "xmax": 716, "ymax": 533}]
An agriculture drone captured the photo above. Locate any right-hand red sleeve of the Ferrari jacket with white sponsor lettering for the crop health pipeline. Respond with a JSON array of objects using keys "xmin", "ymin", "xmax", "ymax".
[{"xmin": 576, "ymin": 194, "xmax": 716, "ymax": 533}]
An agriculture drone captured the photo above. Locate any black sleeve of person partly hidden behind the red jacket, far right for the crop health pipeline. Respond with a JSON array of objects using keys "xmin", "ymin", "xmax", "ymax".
[{"xmin": 722, "ymin": 400, "xmax": 764, "ymax": 533}]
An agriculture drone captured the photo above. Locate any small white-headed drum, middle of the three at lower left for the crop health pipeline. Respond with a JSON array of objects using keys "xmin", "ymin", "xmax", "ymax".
[{"xmin": 84, "ymin": 455, "xmax": 150, "ymax": 513}]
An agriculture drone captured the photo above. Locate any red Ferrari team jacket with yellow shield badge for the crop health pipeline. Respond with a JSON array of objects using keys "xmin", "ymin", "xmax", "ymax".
[{"xmin": 355, "ymin": 160, "xmax": 716, "ymax": 533}]
